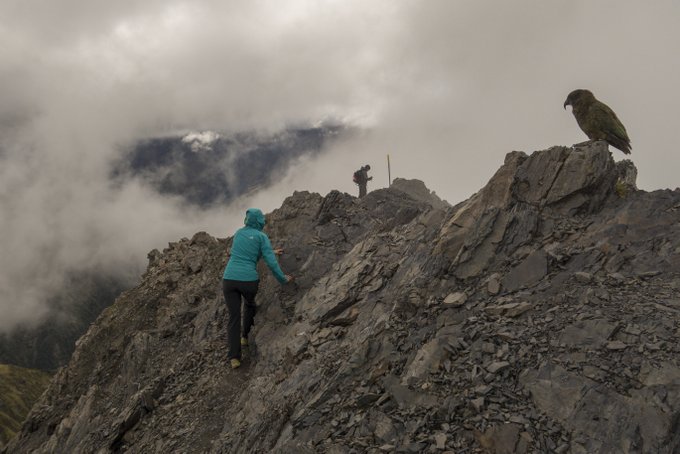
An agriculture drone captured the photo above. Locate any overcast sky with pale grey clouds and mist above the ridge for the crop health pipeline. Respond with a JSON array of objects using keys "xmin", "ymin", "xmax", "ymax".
[{"xmin": 0, "ymin": 0, "xmax": 680, "ymax": 330}]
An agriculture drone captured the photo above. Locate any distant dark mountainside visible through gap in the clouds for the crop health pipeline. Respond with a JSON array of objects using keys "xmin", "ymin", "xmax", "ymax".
[{"xmin": 113, "ymin": 125, "xmax": 347, "ymax": 207}]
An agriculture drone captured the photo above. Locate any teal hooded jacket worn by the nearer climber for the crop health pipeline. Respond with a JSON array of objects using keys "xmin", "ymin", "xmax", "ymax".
[{"xmin": 223, "ymin": 208, "xmax": 287, "ymax": 284}]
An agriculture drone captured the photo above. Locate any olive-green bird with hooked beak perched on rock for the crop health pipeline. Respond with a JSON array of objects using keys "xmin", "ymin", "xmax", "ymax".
[{"xmin": 564, "ymin": 89, "xmax": 631, "ymax": 154}]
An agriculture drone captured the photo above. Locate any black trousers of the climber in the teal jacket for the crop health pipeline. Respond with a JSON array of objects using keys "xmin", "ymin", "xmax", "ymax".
[{"xmin": 222, "ymin": 279, "xmax": 260, "ymax": 359}]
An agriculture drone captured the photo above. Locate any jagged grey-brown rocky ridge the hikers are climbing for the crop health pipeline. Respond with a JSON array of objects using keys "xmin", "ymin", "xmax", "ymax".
[{"xmin": 5, "ymin": 143, "xmax": 680, "ymax": 454}]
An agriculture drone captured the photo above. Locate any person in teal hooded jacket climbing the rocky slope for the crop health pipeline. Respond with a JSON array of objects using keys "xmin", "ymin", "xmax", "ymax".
[{"xmin": 222, "ymin": 208, "xmax": 293, "ymax": 369}]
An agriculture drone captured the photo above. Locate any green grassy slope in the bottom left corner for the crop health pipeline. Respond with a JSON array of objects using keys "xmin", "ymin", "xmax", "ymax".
[{"xmin": 0, "ymin": 364, "xmax": 52, "ymax": 446}]
